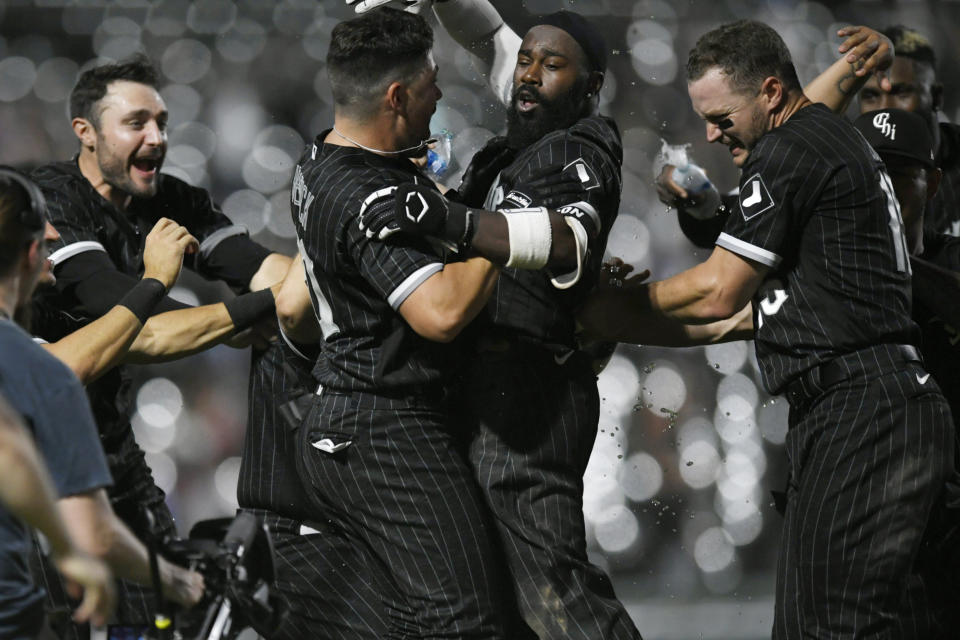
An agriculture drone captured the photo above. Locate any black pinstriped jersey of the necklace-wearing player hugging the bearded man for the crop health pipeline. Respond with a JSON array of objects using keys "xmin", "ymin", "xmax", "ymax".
[{"xmin": 291, "ymin": 132, "xmax": 457, "ymax": 395}]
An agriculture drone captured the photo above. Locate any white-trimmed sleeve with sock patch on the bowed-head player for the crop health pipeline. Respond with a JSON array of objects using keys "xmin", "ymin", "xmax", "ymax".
[{"xmin": 717, "ymin": 134, "xmax": 824, "ymax": 268}]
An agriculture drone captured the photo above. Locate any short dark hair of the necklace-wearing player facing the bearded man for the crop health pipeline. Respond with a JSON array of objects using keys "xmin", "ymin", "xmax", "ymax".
[{"xmin": 327, "ymin": 7, "xmax": 433, "ymax": 118}]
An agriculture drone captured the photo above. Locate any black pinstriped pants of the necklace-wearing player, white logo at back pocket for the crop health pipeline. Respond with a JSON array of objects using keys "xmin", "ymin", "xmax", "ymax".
[{"xmin": 300, "ymin": 391, "xmax": 506, "ymax": 639}]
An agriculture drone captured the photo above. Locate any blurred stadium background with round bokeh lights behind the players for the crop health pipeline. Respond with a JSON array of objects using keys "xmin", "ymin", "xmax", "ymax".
[{"xmin": 0, "ymin": 0, "xmax": 960, "ymax": 639}]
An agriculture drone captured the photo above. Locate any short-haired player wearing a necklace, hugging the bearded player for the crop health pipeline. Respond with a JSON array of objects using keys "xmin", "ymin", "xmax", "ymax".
[{"xmin": 291, "ymin": 9, "xmax": 505, "ymax": 638}]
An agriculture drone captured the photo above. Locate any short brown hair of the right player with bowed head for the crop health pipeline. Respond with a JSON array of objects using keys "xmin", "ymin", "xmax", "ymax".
[{"xmin": 687, "ymin": 20, "xmax": 800, "ymax": 93}]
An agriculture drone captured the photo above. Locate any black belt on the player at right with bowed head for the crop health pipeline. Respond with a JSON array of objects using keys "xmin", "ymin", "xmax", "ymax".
[{"xmin": 785, "ymin": 344, "xmax": 923, "ymax": 405}]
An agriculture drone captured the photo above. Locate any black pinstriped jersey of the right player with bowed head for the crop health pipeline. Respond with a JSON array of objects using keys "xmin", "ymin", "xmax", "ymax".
[{"xmin": 717, "ymin": 104, "xmax": 918, "ymax": 393}]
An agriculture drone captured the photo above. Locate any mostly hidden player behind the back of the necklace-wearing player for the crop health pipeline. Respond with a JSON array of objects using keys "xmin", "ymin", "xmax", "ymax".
[{"xmin": 237, "ymin": 255, "xmax": 387, "ymax": 639}]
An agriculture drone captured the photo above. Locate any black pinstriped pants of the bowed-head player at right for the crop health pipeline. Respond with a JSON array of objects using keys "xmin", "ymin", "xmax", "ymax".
[{"xmin": 773, "ymin": 345, "xmax": 955, "ymax": 640}]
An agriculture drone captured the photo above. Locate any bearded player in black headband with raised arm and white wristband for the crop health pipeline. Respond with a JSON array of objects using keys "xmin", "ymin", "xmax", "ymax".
[{"xmin": 358, "ymin": 1, "xmax": 639, "ymax": 638}]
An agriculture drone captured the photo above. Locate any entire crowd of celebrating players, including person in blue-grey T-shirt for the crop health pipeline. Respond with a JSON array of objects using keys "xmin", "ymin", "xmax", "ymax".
[{"xmin": 0, "ymin": 0, "xmax": 960, "ymax": 639}]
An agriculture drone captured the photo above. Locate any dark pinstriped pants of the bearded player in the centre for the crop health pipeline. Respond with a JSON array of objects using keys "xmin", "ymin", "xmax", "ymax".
[{"xmin": 461, "ymin": 343, "xmax": 640, "ymax": 640}]
